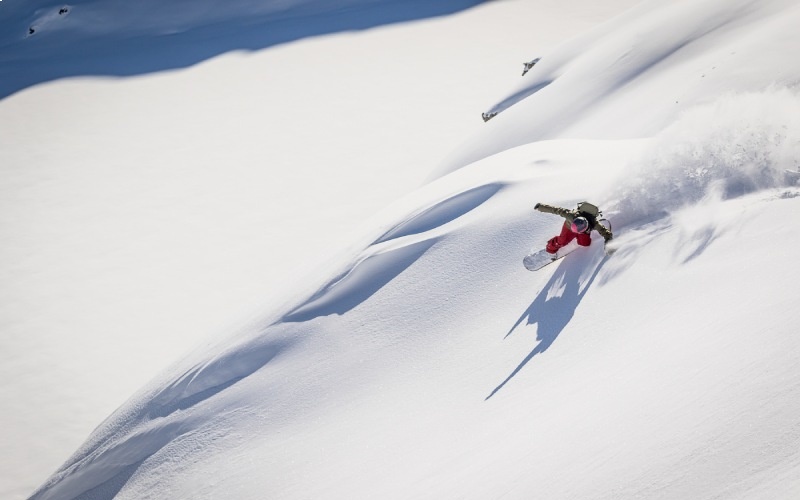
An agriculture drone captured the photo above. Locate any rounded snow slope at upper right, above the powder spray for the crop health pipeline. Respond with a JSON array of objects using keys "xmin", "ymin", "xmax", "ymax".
[{"xmin": 439, "ymin": 0, "xmax": 800, "ymax": 173}]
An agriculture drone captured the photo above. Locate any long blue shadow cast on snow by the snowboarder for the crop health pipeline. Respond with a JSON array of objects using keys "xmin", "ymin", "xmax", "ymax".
[{"xmin": 486, "ymin": 251, "xmax": 608, "ymax": 400}]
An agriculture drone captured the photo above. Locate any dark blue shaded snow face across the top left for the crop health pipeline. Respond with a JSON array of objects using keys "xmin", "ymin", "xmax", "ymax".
[{"xmin": 0, "ymin": 0, "xmax": 482, "ymax": 98}]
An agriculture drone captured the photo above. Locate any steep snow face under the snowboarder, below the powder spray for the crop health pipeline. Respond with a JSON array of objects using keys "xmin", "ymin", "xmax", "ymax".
[{"xmin": 28, "ymin": 141, "xmax": 800, "ymax": 499}]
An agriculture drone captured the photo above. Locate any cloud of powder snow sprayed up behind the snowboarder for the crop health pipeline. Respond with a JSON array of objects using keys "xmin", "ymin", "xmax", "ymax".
[{"xmin": 609, "ymin": 88, "xmax": 800, "ymax": 224}]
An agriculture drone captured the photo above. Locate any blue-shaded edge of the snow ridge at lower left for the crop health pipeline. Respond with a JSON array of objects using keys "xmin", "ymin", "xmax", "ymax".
[{"xmin": 30, "ymin": 336, "xmax": 294, "ymax": 500}]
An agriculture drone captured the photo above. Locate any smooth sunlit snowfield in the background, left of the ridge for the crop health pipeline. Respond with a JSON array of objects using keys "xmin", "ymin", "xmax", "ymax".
[{"xmin": 0, "ymin": 0, "xmax": 635, "ymax": 499}]
